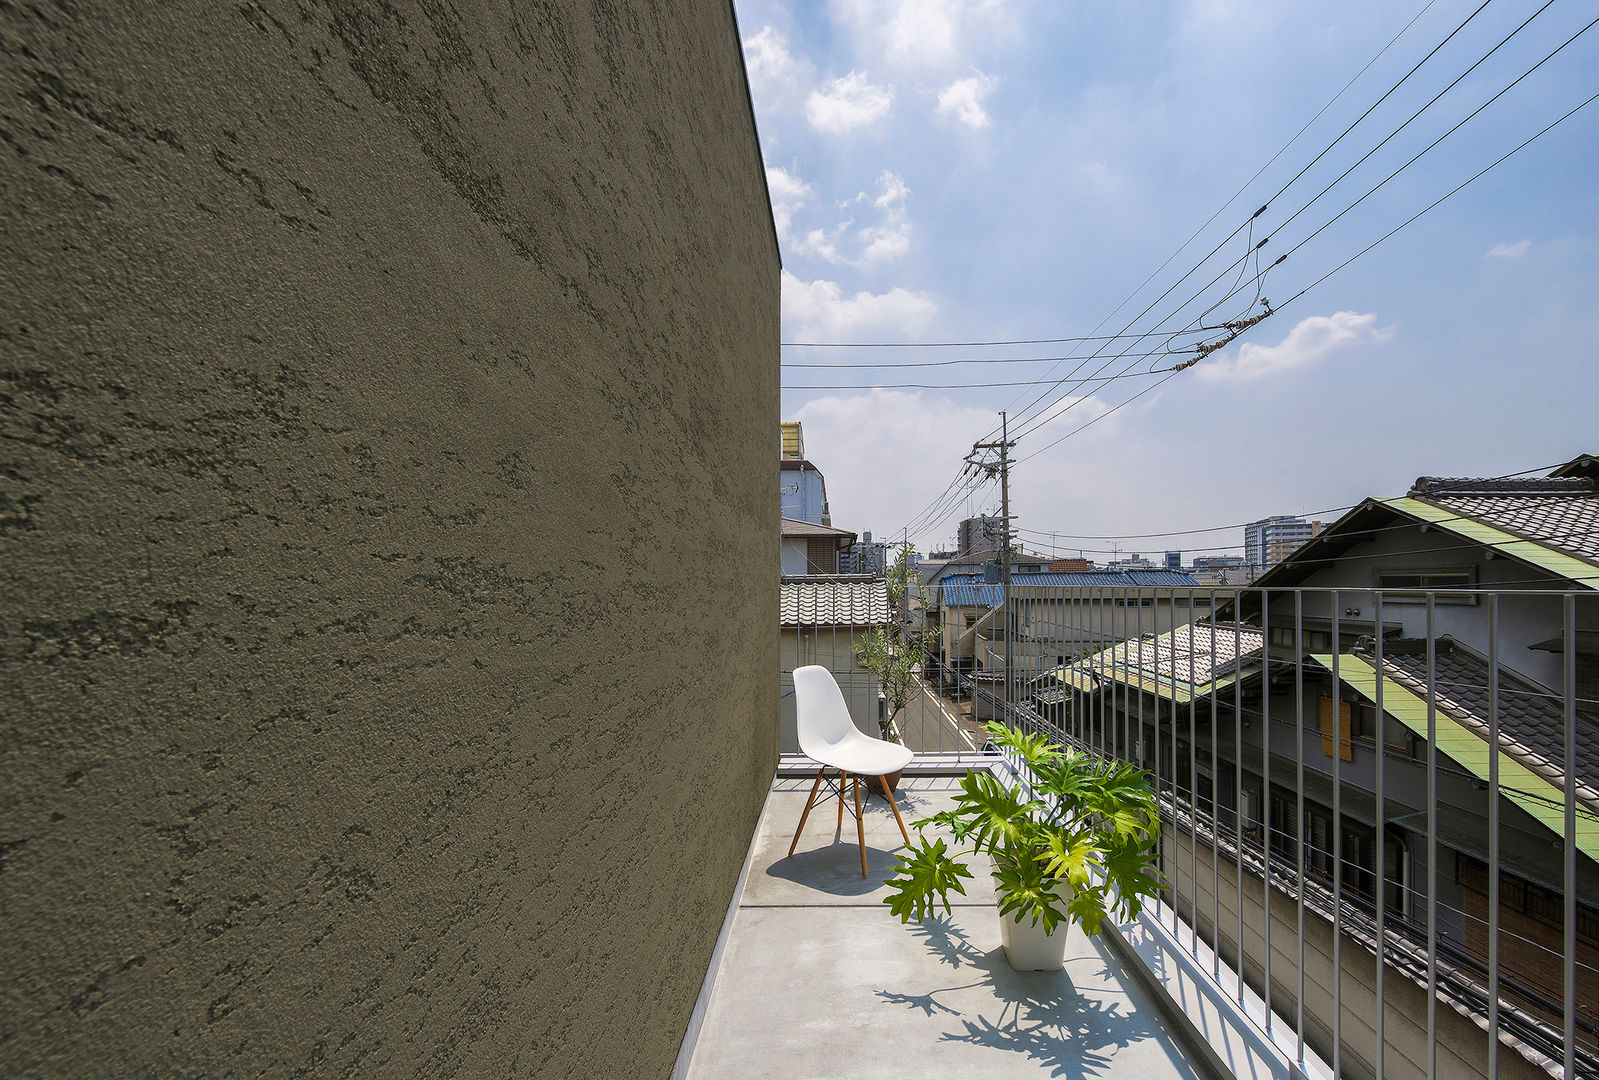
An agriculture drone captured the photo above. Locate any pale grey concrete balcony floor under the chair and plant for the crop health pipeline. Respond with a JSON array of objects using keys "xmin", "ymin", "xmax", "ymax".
[{"xmin": 688, "ymin": 778, "xmax": 1210, "ymax": 1080}]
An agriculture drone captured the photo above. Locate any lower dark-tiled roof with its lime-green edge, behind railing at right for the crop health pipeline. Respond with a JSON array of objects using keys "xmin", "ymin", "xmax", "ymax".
[{"xmin": 1311, "ymin": 638, "xmax": 1599, "ymax": 859}]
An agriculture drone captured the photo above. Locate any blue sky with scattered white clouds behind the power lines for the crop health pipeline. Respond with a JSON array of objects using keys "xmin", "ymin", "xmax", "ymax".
[{"xmin": 736, "ymin": 0, "xmax": 1599, "ymax": 558}]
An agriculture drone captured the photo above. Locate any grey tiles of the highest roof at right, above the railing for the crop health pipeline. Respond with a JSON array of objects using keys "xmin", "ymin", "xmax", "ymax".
[{"xmin": 1409, "ymin": 477, "xmax": 1599, "ymax": 563}]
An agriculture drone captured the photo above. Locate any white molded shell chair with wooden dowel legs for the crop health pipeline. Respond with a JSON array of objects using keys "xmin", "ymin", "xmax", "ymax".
[{"xmin": 788, "ymin": 664, "xmax": 916, "ymax": 877}]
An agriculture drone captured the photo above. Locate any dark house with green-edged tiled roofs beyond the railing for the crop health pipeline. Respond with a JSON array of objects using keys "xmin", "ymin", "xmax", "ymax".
[{"xmin": 1036, "ymin": 459, "xmax": 1599, "ymax": 1075}]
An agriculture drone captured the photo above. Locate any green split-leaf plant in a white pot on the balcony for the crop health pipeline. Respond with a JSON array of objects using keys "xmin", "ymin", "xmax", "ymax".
[{"xmin": 884, "ymin": 723, "xmax": 1162, "ymax": 971}]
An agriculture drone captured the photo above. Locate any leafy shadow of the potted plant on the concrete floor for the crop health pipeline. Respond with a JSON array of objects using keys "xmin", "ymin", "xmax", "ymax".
[{"xmin": 876, "ymin": 917, "xmax": 1180, "ymax": 1080}]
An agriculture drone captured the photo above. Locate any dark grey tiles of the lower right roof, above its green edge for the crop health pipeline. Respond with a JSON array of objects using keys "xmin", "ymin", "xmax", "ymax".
[{"xmin": 1354, "ymin": 635, "xmax": 1599, "ymax": 806}]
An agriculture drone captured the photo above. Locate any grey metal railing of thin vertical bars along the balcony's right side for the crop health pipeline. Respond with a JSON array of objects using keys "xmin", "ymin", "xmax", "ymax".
[{"xmin": 785, "ymin": 586, "xmax": 1599, "ymax": 1077}]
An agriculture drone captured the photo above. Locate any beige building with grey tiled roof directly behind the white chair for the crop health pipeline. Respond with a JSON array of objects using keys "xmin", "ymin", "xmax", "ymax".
[{"xmin": 777, "ymin": 574, "xmax": 891, "ymax": 754}]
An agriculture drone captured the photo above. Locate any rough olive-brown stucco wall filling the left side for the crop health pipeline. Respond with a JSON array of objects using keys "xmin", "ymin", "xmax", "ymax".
[{"xmin": 0, "ymin": 0, "xmax": 779, "ymax": 1077}]
